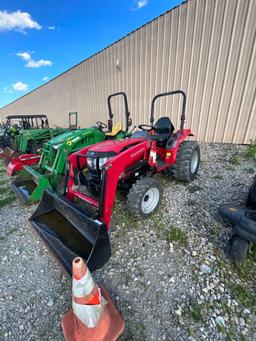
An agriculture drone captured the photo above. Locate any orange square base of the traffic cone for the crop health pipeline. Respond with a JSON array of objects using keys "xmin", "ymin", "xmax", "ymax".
[{"xmin": 61, "ymin": 286, "xmax": 125, "ymax": 341}]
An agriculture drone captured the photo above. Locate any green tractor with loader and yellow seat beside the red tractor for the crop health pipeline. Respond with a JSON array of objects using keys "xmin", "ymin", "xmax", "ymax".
[{"xmin": 12, "ymin": 92, "xmax": 132, "ymax": 204}]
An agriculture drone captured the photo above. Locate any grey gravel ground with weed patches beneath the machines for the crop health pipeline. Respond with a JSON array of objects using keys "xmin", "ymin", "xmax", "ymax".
[{"xmin": 0, "ymin": 144, "xmax": 256, "ymax": 341}]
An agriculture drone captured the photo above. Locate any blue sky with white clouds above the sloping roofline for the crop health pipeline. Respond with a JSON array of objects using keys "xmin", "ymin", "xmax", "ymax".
[{"xmin": 0, "ymin": 0, "xmax": 182, "ymax": 107}]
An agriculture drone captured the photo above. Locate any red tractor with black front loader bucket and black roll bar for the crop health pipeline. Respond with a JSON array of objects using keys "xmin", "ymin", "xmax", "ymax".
[{"xmin": 30, "ymin": 90, "xmax": 200, "ymax": 273}]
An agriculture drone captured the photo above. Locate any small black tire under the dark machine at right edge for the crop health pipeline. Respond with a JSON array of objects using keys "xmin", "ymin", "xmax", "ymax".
[{"xmin": 230, "ymin": 234, "xmax": 250, "ymax": 264}]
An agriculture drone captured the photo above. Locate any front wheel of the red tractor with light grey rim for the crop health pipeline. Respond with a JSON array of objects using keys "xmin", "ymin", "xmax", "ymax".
[{"xmin": 126, "ymin": 177, "xmax": 163, "ymax": 218}]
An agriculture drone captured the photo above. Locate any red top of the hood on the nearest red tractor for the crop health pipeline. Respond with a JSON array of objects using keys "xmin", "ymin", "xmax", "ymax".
[{"xmin": 88, "ymin": 137, "xmax": 145, "ymax": 153}]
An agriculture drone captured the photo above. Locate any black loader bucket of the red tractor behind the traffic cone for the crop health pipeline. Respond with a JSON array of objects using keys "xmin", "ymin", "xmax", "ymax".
[{"xmin": 29, "ymin": 190, "xmax": 111, "ymax": 275}]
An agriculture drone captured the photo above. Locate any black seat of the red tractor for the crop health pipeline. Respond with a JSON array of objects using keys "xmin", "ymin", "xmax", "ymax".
[{"xmin": 150, "ymin": 117, "xmax": 174, "ymax": 147}]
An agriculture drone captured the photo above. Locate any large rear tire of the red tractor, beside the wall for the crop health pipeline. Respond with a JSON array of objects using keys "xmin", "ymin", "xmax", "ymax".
[{"xmin": 170, "ymin": 141, "xmax": 200, "ymax": 182}]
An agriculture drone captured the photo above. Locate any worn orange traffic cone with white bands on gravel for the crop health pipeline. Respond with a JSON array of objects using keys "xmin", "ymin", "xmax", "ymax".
[{"xmin": 61, "ymin": 257, "xmax": 124, "ymax": 341}]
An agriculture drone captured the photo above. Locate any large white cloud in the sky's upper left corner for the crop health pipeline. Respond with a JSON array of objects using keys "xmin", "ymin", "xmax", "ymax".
[{"xmin": 0, "ymin": 11, "xmax": 42, "ymax": 33}]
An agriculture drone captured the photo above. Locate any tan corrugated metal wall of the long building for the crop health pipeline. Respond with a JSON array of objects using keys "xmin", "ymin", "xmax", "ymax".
[{"xmin": 0, "ymin": 0, "xmax": 256, "ymax": 143}]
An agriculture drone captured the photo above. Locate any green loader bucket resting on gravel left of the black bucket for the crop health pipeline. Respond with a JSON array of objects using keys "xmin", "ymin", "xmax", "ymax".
[{"xmin": 11, "ymin": 166, "xmax": 51, "ymax": 204}]
